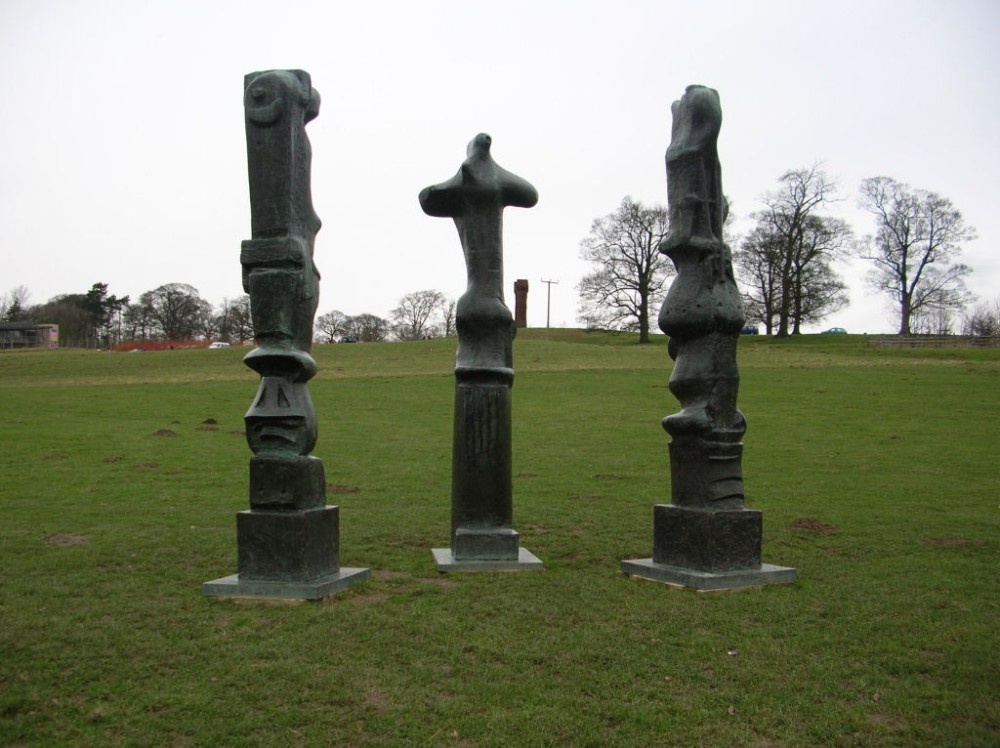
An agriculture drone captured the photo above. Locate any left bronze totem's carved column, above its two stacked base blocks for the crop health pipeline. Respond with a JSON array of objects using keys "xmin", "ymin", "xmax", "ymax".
[{"xmin": 240, "ymin": 70, "xmax": 321, "ymax": 455}]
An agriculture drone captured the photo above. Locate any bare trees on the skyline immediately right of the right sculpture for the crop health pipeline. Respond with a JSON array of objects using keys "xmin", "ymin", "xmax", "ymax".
[{"xmin": 734, "ymin": 164, "xmax": 851, "ymax": 336}]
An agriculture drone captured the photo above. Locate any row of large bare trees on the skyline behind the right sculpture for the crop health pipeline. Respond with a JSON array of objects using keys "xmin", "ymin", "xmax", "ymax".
[{"xmin": 577, "ymin": 165, "xmax": 984, "ymax": 342}]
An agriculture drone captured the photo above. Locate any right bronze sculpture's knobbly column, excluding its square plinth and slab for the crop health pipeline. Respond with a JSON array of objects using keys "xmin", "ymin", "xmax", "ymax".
[{"xmin": 659, "ymin": 86, "xmax": 746, "ymax": 509}]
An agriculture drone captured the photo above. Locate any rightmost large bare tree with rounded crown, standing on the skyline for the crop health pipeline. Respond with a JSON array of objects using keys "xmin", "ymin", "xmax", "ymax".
[{"xmin": 858, "ymin": 177, "xmax": 976, "ymax": 335}]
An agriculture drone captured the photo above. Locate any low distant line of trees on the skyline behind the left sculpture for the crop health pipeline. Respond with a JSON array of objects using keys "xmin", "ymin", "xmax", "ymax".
[{"xmin": 0, "ymin": 283, "xmax": 455, "ymax": 349}]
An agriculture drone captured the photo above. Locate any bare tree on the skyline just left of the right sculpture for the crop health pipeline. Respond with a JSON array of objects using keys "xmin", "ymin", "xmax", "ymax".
[{"xmin": 577, "ymin": 197, "xmax": 674, "ymax": 343}]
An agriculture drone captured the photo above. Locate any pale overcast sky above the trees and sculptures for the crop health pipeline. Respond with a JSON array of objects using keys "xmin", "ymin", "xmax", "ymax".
[{"xmin": 0, "ymin": 0, "xmax": 1000, "ymax": 333}]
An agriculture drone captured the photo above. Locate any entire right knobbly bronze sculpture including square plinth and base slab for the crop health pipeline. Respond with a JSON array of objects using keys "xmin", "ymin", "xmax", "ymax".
[{"xmin": 622, "ymin": 86, "xmax": 795, "ymax": 589}]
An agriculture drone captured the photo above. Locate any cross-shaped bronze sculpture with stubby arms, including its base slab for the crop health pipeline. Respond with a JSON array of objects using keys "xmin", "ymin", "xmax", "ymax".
[{"xmin": 420, "ymin": 133, "xmax": 542, "ymax": 571}]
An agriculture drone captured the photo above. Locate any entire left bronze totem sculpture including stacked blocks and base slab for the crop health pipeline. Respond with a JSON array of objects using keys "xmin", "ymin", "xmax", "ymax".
[{"xmin": 202, "ymin": 70, "xmax": 368, "ymax": 599}]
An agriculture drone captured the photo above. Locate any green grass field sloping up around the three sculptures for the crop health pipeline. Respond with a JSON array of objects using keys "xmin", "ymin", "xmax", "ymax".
[{"xmin": 0, "ymin": 330, "xmax": 1000, "ymax": 748}]
